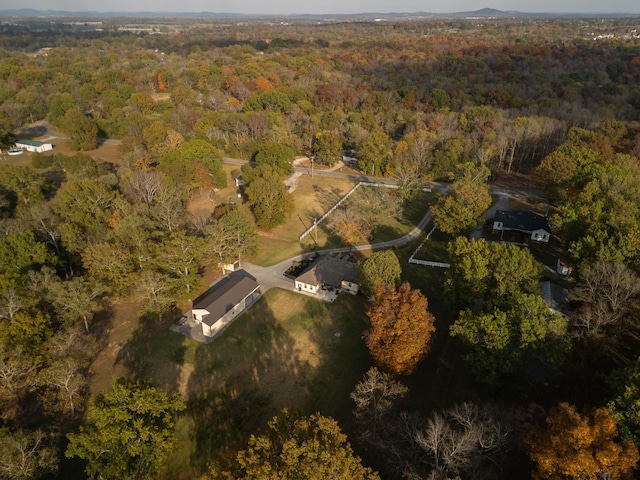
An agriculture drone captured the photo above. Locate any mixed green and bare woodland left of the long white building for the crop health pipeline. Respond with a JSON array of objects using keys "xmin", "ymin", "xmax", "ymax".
[{"xmin": 0, "ymin": 147, "xmax": 257, "ymax": 478}]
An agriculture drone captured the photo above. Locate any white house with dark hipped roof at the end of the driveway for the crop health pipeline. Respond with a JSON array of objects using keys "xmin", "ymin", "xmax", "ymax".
[{"xmin": 294, "ymin": 255, "xmax": 359, "ymax": 295}]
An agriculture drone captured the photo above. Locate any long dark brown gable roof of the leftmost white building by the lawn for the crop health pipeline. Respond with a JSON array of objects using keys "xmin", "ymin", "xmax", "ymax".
[{"xmin": 193, "ymin": 276, "xmax": 260, "ymax": 325}]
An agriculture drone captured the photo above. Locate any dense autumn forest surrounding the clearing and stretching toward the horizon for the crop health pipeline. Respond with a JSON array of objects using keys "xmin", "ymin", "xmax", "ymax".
[{"xmin": 0, "ymin": 13, "xmax": 640, "ymax": 480}]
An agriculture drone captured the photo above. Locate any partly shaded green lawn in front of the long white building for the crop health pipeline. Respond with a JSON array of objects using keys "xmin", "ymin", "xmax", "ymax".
[{"xmin": 123, "ymin": 289, "xmax": 370, "ymax": 479}]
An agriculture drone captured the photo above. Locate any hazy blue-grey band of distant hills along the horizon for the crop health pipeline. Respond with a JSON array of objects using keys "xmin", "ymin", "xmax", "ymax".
[{"xmin": 0, "ymin": 8, "xmax": 640, "ymax": 20}]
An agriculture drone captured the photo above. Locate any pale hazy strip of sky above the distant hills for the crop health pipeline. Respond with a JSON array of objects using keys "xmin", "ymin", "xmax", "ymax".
[{"xmin": 0, "ymin": 0, "xmax": 640, "ymax": 14}]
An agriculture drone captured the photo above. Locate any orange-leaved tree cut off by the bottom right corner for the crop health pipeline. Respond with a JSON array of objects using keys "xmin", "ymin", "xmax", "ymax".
[{"xmin": 525, "ymin": 403, "xmax": 639, "ymax": 480}]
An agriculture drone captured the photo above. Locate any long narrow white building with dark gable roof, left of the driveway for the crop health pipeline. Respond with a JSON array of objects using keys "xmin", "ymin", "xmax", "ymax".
[{"xmin": 188, "ymin": 276, "xmax": 260, "ymax": 337}]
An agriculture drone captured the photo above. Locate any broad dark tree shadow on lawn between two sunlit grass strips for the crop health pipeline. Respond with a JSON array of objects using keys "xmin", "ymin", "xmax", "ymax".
[{"xmin": 181, "ymin": 298, "xmax": 309, "ymax": 478}]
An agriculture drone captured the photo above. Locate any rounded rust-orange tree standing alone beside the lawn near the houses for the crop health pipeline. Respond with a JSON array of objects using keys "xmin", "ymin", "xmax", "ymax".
[{"xmin": 366, "ymin": 283, "xmax": 435, "ymax": 375}]
